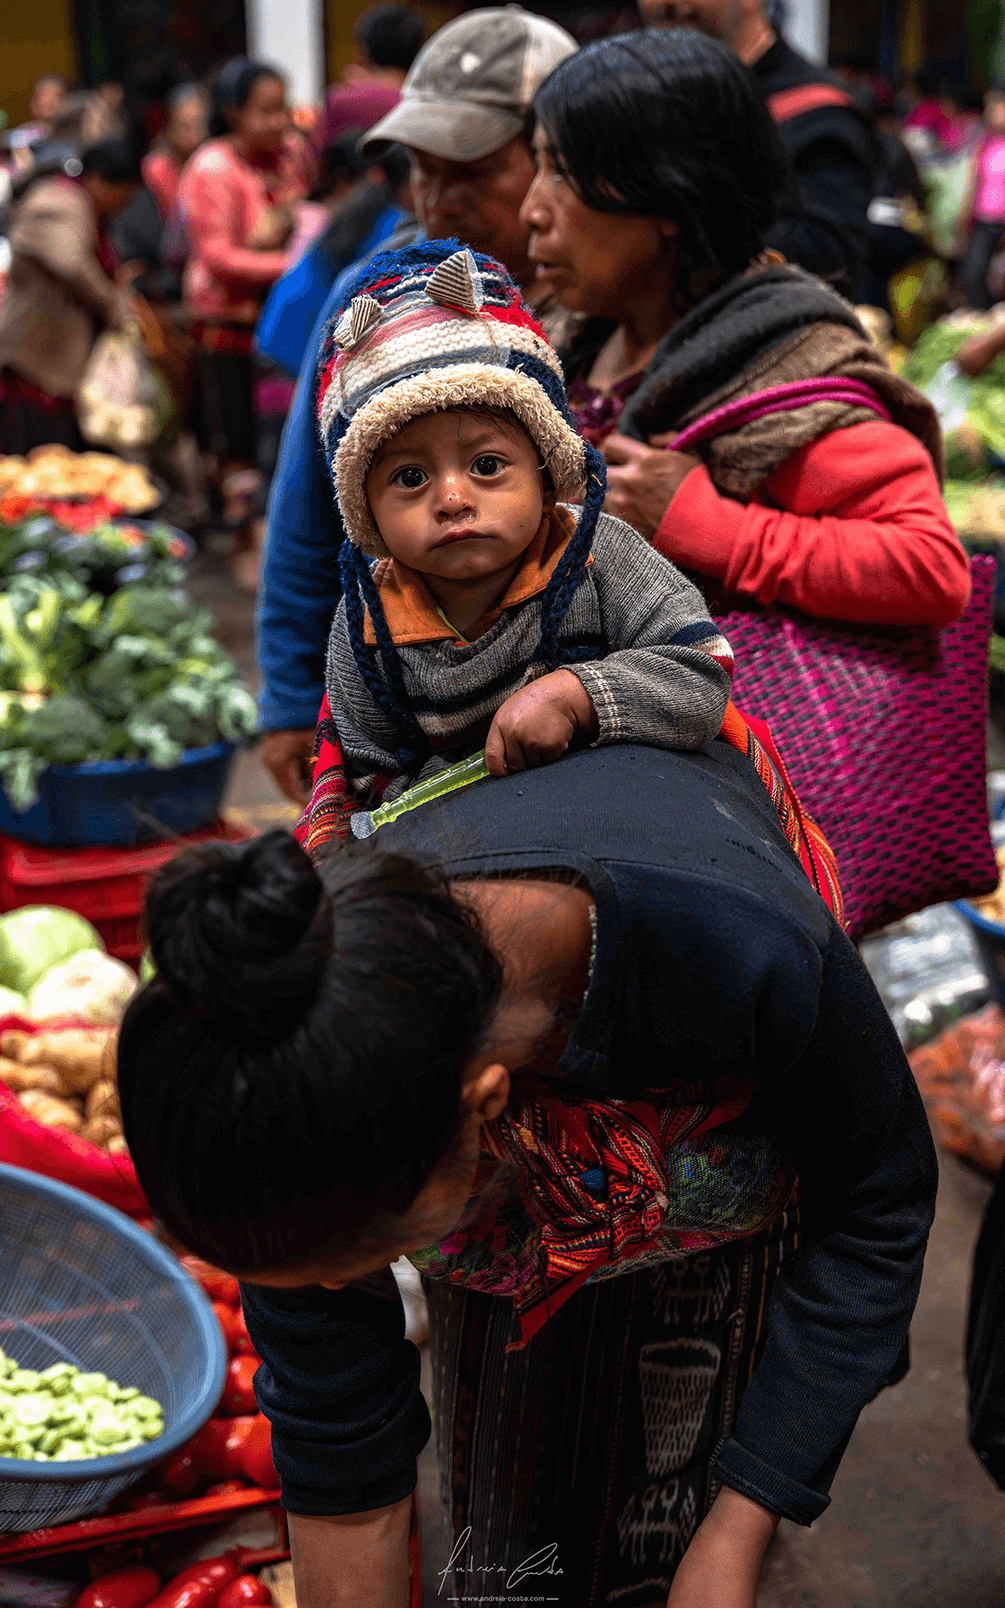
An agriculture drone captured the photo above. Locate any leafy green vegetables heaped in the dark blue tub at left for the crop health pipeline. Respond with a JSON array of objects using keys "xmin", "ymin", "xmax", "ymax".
[{"xmin": 0, "ymin": 572, "xmax": 256, "ymax": 814}]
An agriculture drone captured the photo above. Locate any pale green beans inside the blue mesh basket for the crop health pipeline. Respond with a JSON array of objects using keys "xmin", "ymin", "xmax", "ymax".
[{"xmin": 0, "ymin": 1351, "xmax": 164, "ymax": 1463}]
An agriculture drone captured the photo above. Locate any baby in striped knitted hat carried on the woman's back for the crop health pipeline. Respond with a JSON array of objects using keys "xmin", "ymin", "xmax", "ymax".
[{"xmin": 311, "ymin": 241, "xmax": 733, "ymax": 807}]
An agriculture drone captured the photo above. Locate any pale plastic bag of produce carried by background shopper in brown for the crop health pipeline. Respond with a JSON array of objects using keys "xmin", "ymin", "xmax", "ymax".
[{"xmin": 77, "ymin": 328, "xmax": 174, "ymax": 452}]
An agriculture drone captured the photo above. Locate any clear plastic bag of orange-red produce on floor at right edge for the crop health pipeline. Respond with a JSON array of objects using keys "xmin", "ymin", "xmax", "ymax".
[{"xmin": 909, "ymin": 1005, "xmax": 1005, "ymax": 1177}]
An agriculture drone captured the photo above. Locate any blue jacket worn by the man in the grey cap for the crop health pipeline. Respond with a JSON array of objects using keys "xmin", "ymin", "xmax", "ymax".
[{"xmin": 256, "ymin": 209, "xmax": 416, "ymax": 732}]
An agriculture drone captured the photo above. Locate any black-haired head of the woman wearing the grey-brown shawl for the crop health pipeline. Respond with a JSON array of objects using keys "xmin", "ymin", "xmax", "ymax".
[{"xmin": 521, "ymin": 29, "xmax": 788, "ymax": 317}]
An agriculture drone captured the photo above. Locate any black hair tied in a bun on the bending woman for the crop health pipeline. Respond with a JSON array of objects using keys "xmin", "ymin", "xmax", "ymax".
[{"xmin": 119, "ymin": 831, "xmax": 502, "ymax": 1275}]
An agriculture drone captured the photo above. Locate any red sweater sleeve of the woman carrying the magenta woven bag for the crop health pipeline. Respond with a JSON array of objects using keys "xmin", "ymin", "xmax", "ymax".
[{"xmin": 654, "ymin": 421, "xmax": 970, "ymax": 626}]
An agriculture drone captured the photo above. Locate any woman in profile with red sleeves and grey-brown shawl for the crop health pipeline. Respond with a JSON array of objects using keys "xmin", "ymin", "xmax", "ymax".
[{"xmin": 523, "ymin": 29, "xmax": 970, "ymax": 626}]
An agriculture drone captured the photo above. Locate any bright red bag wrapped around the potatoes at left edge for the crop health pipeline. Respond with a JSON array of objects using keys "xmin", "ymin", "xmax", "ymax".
[{"xmin": 0, "ymin": 1016, "xmax": 150, "ymax": 1217}]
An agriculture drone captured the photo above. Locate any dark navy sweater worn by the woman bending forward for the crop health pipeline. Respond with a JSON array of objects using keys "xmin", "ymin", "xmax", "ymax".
[{"xmin": 244, "ymin": 741, "xmax": 936, "ymax": 1523}]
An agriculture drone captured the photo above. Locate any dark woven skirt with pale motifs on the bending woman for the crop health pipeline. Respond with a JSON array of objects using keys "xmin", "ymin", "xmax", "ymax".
[{"xmin": 423, "ymin": 1211, "xmax": 798, "ymax": 1608}]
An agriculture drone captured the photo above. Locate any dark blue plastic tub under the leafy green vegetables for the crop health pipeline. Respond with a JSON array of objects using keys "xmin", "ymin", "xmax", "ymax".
[{"xmin": 0, "ymin": 743, "xmax": 235, "ymax": 849}]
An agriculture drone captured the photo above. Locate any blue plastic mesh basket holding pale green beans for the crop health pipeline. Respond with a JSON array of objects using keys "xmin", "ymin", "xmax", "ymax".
[{"xmin": 0, "ymin": 1166, "xmax": 227, "ymax": 1531}]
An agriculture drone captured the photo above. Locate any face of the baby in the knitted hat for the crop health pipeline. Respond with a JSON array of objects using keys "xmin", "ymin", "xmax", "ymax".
[{"xmin": 367, "ymin": 408, "xmax": 553, "ymax": 580}]
